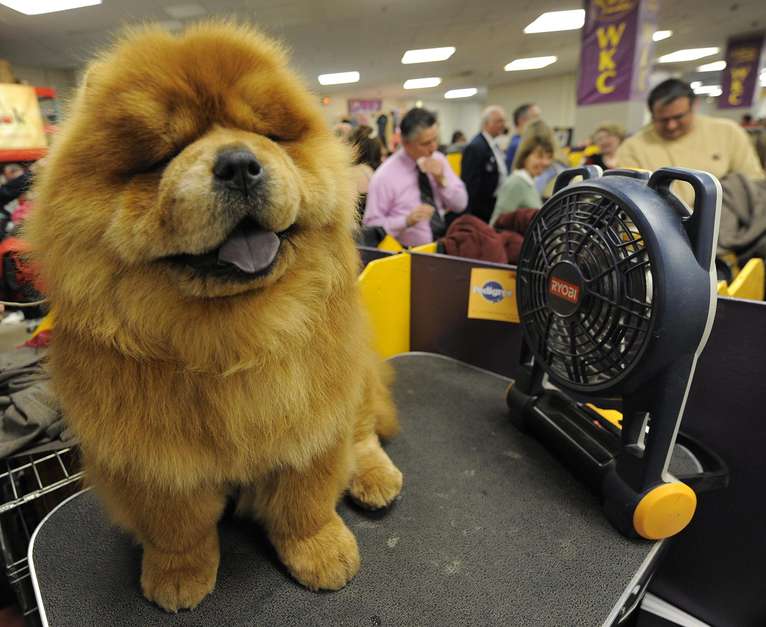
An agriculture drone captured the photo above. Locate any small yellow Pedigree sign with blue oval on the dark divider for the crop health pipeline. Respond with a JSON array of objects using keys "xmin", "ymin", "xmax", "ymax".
[{"xmin": 468, "ymin": 268, "xmax": 519, "ymax": 322}]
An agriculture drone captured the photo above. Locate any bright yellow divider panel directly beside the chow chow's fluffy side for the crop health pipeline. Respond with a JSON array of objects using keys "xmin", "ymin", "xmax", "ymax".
[{"xmin": 359, "ymin": 254, "xmax": 412, "ymax": 358}]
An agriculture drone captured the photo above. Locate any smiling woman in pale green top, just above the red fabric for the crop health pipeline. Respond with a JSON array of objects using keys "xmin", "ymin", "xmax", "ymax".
[{"xmin": 496, "ymin": 120, "xmax": 556, "ymax": 226}]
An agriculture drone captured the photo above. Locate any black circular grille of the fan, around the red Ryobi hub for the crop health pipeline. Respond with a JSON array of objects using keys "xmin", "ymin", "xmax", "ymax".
[{"xmin": 517, "ymin": 190, "xmax": 655, "ymax": 389}]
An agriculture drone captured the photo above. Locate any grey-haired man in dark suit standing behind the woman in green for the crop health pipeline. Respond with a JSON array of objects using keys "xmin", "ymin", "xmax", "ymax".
[{"xmin": 460, "ymin": 105, "xmax": 508, "ymax": 222}]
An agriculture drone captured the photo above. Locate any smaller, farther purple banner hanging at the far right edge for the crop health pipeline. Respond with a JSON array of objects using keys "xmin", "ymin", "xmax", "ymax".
[{"xmin": 718, "ymin": 33, "xmax": 763, "ymax": 109}]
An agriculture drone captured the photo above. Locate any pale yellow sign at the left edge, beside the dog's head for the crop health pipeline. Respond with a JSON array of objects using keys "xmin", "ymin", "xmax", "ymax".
[{"xmin": 0, "ymin": 84, "xmax": 48, "ymax": 150}]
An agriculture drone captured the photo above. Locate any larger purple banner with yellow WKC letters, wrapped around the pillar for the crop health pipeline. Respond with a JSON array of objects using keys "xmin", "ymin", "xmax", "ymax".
[{"xmin": 577, "ymin": 0, "xmax": 657, "ymax": 105}]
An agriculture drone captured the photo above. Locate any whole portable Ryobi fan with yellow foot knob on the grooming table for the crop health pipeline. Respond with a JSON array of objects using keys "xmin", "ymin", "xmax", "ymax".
[{"xmin": 507, "ymin": 166, "xmax": 725, "ymax": 539}]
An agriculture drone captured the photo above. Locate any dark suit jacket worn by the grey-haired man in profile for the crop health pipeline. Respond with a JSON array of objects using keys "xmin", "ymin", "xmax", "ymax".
[{"xmin": 460, "ymin": 133, "xmax": 500, "ymax": 223}]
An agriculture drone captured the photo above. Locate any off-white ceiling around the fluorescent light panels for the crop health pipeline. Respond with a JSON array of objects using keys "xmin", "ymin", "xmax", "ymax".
[{"xmin": 0, "ymin": 0, "xmax": 766, "ymax": 98}]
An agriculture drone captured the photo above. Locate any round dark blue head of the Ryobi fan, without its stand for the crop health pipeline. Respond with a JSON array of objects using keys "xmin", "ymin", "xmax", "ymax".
[{"xmin": 517, "ymin": 170, "xmax": 715, "ymax": 393}]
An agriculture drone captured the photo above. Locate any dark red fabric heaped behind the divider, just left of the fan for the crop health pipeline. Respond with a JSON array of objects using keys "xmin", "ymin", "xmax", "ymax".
[{"xmin": 442, "ymin": 209, "xmax": 539, "ymax": 264}]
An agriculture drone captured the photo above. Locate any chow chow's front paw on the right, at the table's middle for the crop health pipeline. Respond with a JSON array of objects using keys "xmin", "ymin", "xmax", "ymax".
[{"xmin": 272, "ymin": 514, "xmax": 360, "ymax": 590}]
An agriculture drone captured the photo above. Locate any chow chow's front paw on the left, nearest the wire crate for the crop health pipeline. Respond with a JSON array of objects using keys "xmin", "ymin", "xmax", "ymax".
[{"xmin": 141, "ymin": 536, "xmax": 219, "ymax": 612}]
